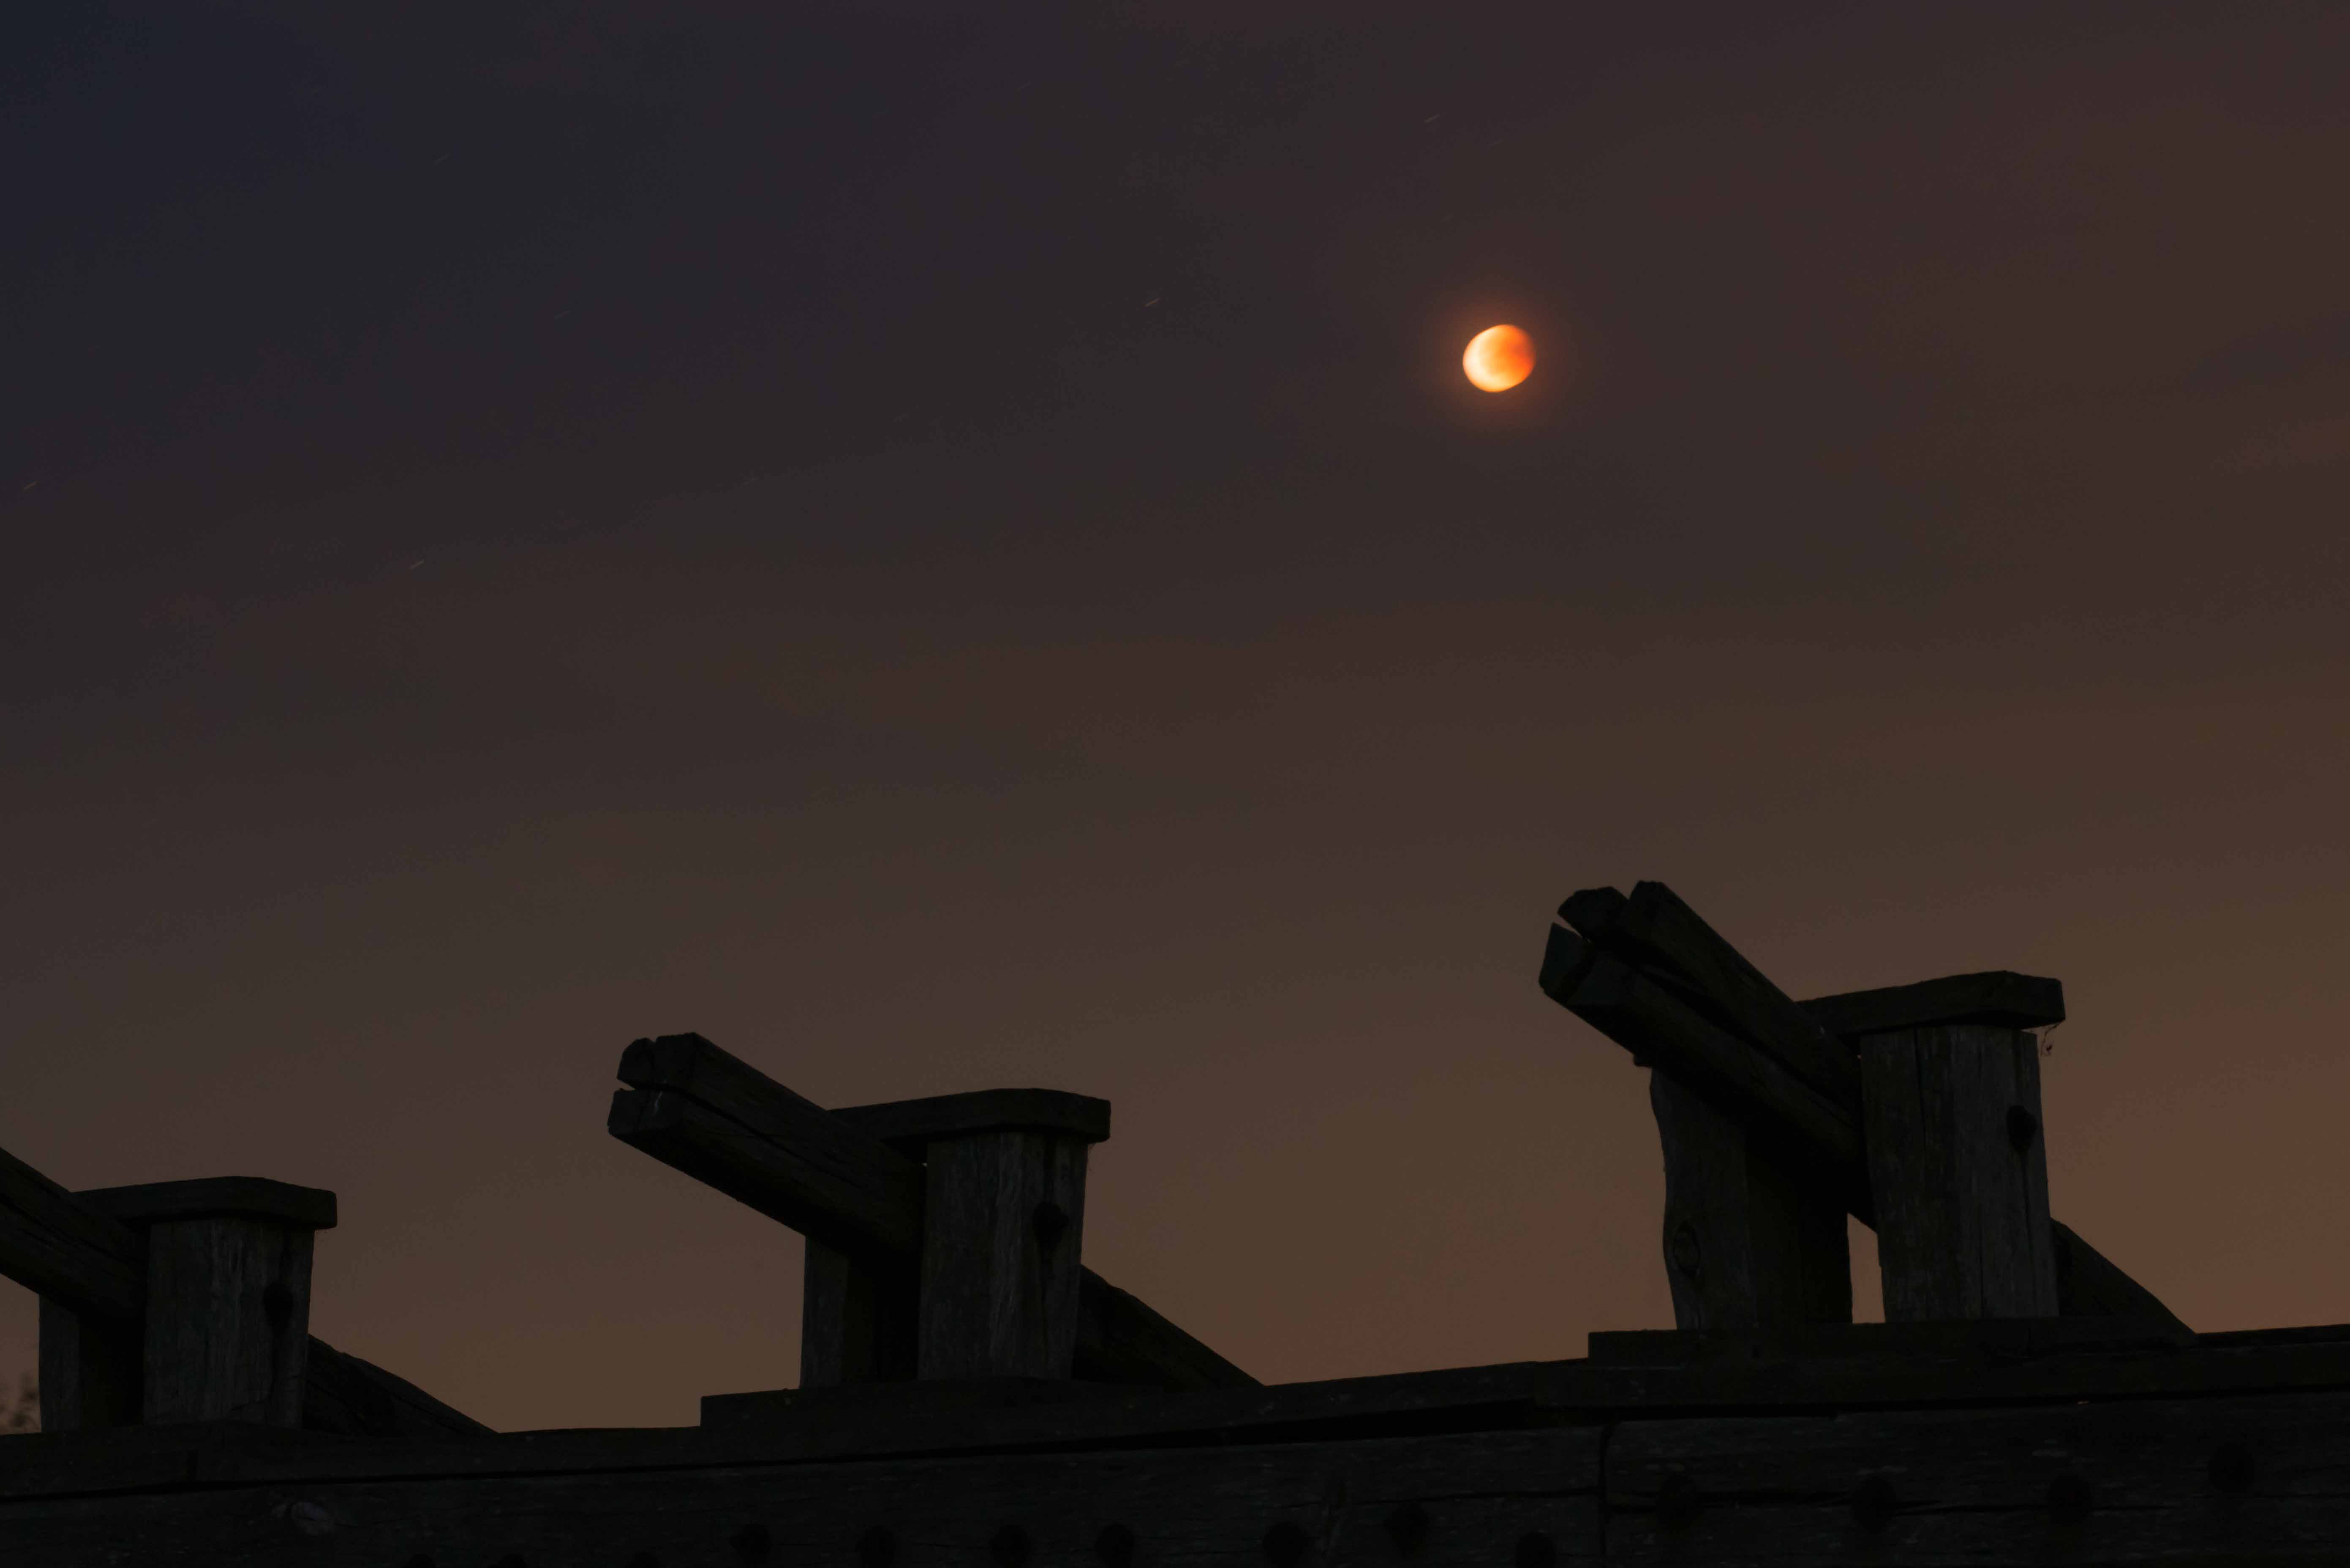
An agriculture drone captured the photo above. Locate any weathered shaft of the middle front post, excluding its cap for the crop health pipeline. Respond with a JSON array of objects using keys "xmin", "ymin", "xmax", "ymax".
[{"xmin": 919, "ymin": 1131, "xmax": 1086, "ymax": 1378}]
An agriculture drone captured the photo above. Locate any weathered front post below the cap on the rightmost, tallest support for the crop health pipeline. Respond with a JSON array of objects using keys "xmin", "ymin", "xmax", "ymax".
[{"xmin": 1857, "ymin": 1023, "xmax": 2056, "ymax": 1323}]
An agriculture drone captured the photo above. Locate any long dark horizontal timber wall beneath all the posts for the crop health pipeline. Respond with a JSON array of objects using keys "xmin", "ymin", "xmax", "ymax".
[{"xmin": 14, "ymin": 1326, "xmax": 2350, "ymax": 1568}]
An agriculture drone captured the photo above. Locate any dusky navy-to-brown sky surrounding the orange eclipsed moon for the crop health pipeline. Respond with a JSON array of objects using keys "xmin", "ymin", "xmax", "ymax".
[{"xmin": 0, "ymin": 0, "xmax": 2350, "ymax": 1427}]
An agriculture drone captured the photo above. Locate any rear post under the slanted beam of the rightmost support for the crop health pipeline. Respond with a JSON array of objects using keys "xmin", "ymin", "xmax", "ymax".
[{"xmin": 1647, "ymin": 1072, "xmax": 1852, "ymax": 1333}]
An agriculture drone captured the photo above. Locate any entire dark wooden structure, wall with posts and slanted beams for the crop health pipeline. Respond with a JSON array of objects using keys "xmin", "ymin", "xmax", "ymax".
[{"xmin": 0, "ymin": 882, "xmax": 2350, "ymax": 1568}]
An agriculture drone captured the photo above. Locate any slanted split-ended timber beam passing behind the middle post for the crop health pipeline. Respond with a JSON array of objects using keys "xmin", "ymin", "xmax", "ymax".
[{"xmin": 606, "ymin": 1034, "xmax": 1257, "ymax": 1389}]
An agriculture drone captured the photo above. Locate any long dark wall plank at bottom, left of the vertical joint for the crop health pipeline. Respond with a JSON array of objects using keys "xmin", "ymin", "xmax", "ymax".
[{"xmin": 0, "ymin": 1429, "xmax": 1600, "ymax": 1568}]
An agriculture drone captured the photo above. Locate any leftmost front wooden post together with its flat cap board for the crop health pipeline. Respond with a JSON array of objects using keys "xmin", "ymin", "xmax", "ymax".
[{"xmin": 80, "ymin": 1175, "xmax": 336, "ymax": 1427}]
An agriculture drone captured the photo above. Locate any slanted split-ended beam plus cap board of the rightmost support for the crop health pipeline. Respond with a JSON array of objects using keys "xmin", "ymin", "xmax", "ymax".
[{"xmin": 1539, "ymin": 882, "xmax": 2188, "ymax": 1333}]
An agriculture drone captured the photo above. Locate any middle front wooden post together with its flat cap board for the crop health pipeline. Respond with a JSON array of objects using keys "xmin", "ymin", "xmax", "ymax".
[{"xmin": 834, "ymin": 1088, "xmax": 1109, "ymax": 1378}]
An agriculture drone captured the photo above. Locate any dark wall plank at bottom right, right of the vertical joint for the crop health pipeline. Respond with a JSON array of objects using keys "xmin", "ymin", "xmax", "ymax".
[{"xmin": 1607, "ymin": 1391, "xmax": 2350, "ymax": 1568}]
